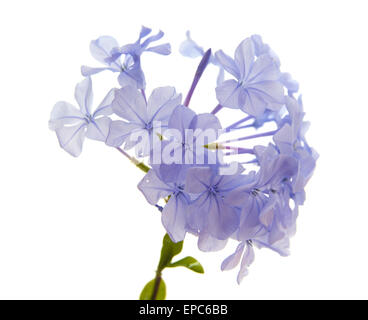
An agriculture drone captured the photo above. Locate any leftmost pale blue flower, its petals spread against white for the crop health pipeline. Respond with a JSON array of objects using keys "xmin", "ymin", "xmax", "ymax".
[{"xmin": 49, "ymin": 77, "xmax": 114, "ymax": 157}]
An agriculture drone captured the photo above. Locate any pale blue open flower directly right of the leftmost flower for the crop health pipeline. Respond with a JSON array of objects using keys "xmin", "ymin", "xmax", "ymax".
[{"xmin": 106, "ymin": 86, "xmax": 181, "ymax": 156}]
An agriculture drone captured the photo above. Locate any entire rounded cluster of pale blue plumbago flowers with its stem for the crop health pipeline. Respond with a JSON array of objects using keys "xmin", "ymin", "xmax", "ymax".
[{"xmin": 49, "ymin": 27, "xmax": 318, "ymax": 298}]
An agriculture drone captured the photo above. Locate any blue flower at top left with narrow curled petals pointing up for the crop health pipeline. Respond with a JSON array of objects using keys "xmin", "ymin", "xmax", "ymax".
[{"xmin": 81, "ymin": 27, "xmax": 171, "ymax": 89}]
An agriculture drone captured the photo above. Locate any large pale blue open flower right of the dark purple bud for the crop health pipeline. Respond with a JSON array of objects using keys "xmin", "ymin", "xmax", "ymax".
[{"xmin": 216, "ymin": 38, "xmax": 284, "ymax": 117}]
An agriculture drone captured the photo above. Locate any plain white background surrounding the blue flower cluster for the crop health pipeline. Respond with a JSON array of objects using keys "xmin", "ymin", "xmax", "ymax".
[{"xmin": 0, "ymin": 0, "xmax": 368, "ymax": 299}]
